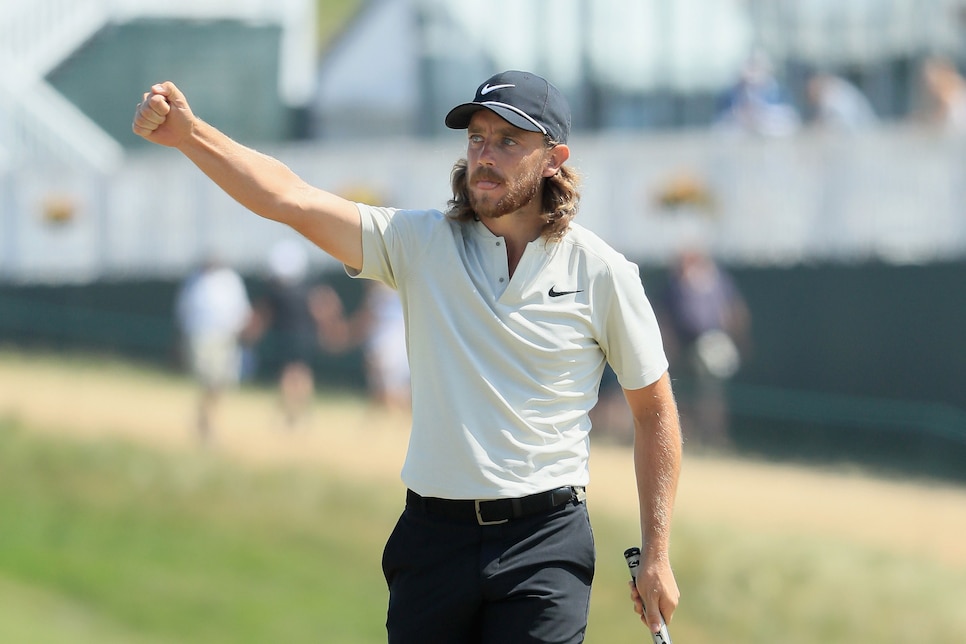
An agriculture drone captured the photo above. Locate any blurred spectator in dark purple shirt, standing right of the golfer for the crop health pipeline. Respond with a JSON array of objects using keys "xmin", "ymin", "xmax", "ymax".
[{"xmin": 661, "ymin": 250, "xmax": 751, "ymax": 447}]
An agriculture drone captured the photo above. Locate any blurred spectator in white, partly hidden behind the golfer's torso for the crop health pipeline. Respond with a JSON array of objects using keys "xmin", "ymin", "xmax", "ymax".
[{"xmin": 312, "ymin": 280, "xmax": 411, "ymax": 411}]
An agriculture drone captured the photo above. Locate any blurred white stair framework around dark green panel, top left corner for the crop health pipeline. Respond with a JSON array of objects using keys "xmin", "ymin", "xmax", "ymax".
[{"xmin": 0, "ymin": 0, "xmax": 315, "ymax": 173}]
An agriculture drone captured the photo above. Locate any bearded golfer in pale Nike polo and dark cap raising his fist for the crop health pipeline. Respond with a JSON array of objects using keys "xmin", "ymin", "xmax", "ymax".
[{"xmin": 133, "ymin": 71, "xmax": 681, "ymax": 642}]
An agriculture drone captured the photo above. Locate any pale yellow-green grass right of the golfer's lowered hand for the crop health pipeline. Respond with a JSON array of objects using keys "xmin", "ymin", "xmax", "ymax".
[{"xmin": 677, "ymin": 526, "xmax": 966, "ymax": 644}]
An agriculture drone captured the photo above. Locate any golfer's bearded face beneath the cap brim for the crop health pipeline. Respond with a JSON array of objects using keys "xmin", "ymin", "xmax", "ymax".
[{"xmin": 466, "ymin": 109, "xmax": 549, "ymax": 218}]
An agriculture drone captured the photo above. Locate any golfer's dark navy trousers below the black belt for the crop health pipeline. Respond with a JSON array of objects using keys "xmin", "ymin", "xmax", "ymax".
[{"xmin": 382, "ymin": 494, "xmax": 596, "ymax": 644}]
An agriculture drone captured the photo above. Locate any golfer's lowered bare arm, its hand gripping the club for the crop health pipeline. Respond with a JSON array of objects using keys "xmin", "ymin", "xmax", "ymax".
[{"xmin": 624, "ymin": 373, "xmax": 681, "ymax": 633}]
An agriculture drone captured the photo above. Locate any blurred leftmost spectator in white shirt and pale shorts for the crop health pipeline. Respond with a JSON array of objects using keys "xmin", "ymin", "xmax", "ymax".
[{"xmin": 175, "ymin": 259, "xmax": 252, "ymax": 441}]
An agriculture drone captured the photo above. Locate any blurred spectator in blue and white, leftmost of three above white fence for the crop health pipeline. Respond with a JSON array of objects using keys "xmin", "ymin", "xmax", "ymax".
[{"xmin": 715, "ymin": 52, "xmax": 801, "ymax": 137}]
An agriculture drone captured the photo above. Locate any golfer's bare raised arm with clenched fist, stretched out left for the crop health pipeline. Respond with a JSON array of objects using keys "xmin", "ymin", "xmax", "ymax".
[{"xmin": 132, "ymin": 82, "xmax": 362, "ymax": 269}]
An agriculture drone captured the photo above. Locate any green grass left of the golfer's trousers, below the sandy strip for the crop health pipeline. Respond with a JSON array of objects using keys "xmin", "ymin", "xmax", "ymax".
[{"xmin": 0, "ymin": 425, "xmax": 394, "ymax": 643}]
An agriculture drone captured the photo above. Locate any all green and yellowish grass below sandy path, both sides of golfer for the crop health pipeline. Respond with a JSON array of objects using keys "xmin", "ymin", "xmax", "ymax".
[{"xmin": 0, "ymin": 354, "xmax": 966, "ymax": 644}]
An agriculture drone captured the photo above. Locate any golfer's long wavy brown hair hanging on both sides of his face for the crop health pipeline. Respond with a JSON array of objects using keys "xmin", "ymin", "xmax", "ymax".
[{"xmin": 446, "ymin": 159, "xmax": 580, "ymax": 241}]
